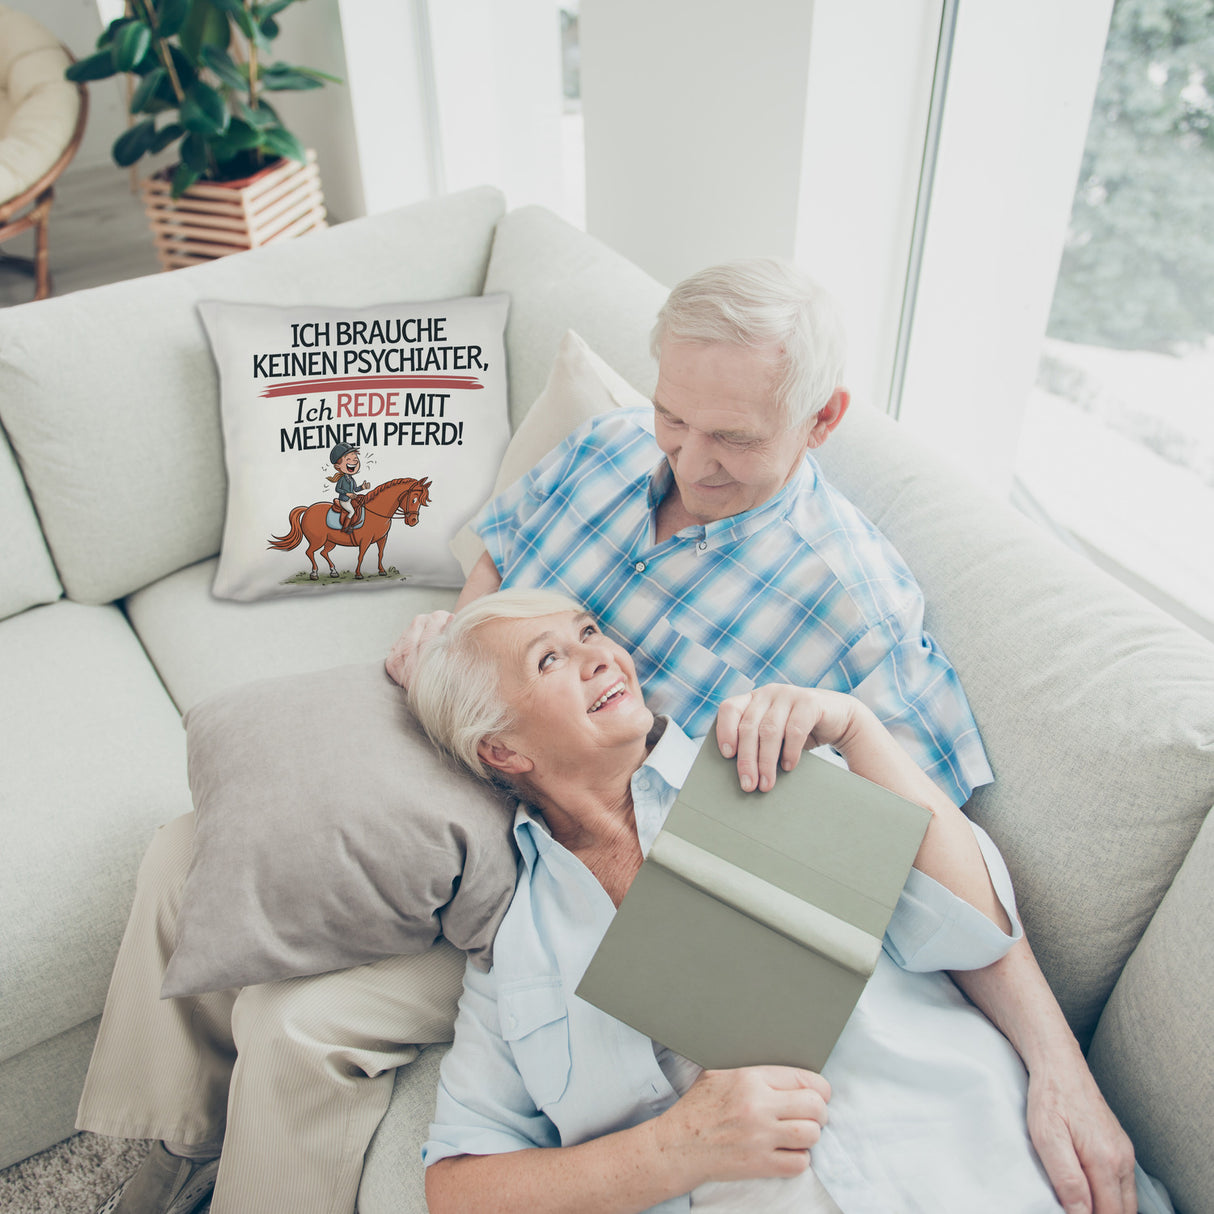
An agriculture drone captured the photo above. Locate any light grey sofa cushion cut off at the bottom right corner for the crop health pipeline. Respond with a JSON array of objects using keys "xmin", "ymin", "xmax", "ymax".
[{"xmin": 1088, "ymin": 813, "xmax": 1214, "ymax": 1210}]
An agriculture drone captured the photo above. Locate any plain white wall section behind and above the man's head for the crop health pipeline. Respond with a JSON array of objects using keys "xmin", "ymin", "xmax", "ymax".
[{"xmin": 580, "ymin": 0, "xmax": 815, "ymax": 283}]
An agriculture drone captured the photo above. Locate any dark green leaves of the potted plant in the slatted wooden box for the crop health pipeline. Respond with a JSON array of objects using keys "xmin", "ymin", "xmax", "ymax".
[{"xmin": 67, "ymin": 0, "xmax": 336, "ymax": 197}]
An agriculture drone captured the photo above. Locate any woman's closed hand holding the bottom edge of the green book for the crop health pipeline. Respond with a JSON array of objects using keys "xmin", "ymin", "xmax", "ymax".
[{"xmin": 654, "ymin": 1066, "xmax": 830, "ymax": 1187}]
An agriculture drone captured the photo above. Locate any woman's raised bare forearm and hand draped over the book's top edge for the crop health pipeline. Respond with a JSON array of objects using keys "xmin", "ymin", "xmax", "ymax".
[{"xmin": 716, "ymin": 683, "xmax": 1012, "ymax": 934}]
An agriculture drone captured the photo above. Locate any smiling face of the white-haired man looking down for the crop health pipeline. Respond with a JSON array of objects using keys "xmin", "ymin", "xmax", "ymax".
[{"xmin": 653, "ymin": 341, "xmax": 817, "ymax": 523}]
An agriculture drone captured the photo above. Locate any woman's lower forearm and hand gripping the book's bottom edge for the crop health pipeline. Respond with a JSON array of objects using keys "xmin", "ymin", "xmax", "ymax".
[{"xmin": 426, "ymin": 1066, "xmax": 830, "ymax": 1214}]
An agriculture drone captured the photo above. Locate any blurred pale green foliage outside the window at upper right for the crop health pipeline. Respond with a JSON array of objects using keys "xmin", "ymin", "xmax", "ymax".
[{"xmin": 1049, "ymin": 0, "xmax": 1214, "ymax": 352}]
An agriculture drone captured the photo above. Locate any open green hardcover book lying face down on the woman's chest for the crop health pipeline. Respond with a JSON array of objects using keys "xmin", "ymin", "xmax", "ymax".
[{"xmin": 577, "ymin": 736, "xmax": 931, "ymax": 1071}]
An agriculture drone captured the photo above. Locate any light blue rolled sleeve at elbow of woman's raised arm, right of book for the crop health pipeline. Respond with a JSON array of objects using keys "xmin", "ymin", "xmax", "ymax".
[{"xmin": 884, "ymin": 822, "xmax": 1025, "ymax": 972}]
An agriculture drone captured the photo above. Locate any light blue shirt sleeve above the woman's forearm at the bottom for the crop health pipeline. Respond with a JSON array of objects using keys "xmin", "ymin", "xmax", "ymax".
[{"xmin": 421, "ymin": 964, "xmax": 560, "ymax": 1168}]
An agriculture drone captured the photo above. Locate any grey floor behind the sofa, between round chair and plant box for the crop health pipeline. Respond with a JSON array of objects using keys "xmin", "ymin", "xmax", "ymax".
[{"xmin": 0, "ymin": 164, "xmax": 160, "ymax": 307}]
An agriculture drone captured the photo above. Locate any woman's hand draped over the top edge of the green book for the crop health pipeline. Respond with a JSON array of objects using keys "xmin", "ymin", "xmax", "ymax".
[{"xmin": 716, "ymin": 683, "xmax": 867, "ymax": 793}]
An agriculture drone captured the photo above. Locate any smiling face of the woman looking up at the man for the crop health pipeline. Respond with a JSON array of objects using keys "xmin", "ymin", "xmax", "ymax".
[{"xmin": 477, "ymin": 611, "xmax": 653, "ymax": 773}]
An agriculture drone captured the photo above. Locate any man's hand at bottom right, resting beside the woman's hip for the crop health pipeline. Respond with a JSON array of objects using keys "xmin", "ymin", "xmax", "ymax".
[{"xmin": 1028, "ymin": 1062, "xmax": 1138, "ymax": 1214}]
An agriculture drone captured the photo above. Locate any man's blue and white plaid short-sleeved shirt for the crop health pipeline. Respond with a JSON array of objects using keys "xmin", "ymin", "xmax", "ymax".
[{"xmin": 473, "ymin": 408, "xmax": 993, "ymax": 805}]
